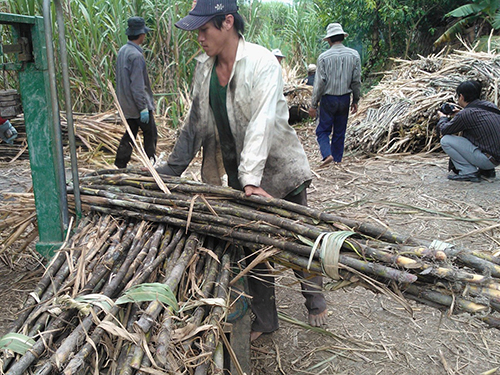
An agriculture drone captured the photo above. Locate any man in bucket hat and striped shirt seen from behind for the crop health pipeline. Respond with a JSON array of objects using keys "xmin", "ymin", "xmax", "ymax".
[{"xmin": 309, "ymin": 23, "xmax": 361, "ymax": 167}]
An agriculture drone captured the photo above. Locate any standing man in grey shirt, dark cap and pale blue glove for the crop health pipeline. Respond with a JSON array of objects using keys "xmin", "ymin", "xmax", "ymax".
[{"xmin": 115, "ymin": 17, "xmax": 158, "ymax": 168}]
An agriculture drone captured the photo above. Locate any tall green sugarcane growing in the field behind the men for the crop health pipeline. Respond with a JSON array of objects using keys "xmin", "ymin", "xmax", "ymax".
[{"xmin": 0, "ymin": 0, "xmax": 327, "ymax": 126}]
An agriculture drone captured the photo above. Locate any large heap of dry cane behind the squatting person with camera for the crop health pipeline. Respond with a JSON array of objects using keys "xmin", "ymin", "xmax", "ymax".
[{"xmin": 346, "ymin": 51, "xmax": 500, "ymax": 153}]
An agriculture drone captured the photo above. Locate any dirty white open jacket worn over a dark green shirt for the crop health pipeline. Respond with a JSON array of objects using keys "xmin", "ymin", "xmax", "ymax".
[{"xmin": 157, "ymin": 37, "xmax": 312, "ymax": 198}]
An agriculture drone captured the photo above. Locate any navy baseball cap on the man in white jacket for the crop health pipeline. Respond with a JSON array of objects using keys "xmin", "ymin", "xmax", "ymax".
[{"xmin": 175, "ymin": 0, "xmax": 238, "ymax": 31}]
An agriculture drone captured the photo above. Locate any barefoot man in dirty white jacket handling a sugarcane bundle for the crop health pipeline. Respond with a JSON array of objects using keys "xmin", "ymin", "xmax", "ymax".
[{"xmin": 157, "ymin": 0, "xmax": 327, "ymax": 340}]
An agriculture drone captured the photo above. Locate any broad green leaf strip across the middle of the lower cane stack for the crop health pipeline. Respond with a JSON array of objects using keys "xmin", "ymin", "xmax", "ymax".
[{"xmin": 115, "ymin": 283, "xmax": 179, "ymax": 311}]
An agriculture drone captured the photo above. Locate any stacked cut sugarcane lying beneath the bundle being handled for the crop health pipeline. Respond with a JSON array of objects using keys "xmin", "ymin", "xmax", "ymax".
[{"xmin": 0, "ymin": 214, "xmax": 254, "ymax": 375}]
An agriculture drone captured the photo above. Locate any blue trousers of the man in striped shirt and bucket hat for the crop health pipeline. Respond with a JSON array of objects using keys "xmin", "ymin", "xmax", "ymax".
[{"xmin": 316, "ymin": 94, "xmax": 351, "ymax": 162}]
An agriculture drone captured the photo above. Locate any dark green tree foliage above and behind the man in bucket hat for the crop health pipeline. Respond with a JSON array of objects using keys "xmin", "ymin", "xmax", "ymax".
[{"xmin": 314, "ymin": 0, "xmax": 470, "ymax": 72}]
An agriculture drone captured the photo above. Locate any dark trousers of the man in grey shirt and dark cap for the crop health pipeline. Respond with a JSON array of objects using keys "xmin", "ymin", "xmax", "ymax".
[{"xmin": 115, "ymin": 111, "xmax": 158, "ymax": 168}]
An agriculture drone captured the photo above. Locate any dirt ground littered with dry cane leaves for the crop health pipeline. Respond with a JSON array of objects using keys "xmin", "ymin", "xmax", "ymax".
[{"xmin": 0, "ymin": 126, "xmax": 500, "ymax": 375}]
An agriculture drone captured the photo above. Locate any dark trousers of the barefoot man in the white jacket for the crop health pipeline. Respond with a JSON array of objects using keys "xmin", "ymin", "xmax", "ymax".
[{"xmin": 246, "ymin": 189, "xmax": 326, "ymax": 333}]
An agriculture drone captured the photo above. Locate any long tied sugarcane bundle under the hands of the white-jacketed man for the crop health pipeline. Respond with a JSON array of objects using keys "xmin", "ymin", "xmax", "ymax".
[{"xmin": 68, "ymin": 170, "xmax": 500, "ymax": 325}]
